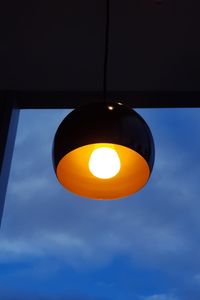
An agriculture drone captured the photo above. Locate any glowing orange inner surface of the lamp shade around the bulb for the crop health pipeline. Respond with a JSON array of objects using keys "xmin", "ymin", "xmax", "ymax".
[{"xmin": 56, "ymin": 143, "xmax": 150, "ymax": 200}]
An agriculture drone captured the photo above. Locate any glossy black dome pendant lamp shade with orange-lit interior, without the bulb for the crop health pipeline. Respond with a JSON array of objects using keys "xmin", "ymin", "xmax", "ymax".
[{"xmin": 53, "ymin": 103, "xmax": 154, "ymax": 200}]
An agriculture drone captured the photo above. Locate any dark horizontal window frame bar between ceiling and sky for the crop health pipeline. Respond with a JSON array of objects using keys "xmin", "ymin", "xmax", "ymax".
[{"xmin": 0, "ymin": 90, "xmax": 200, "ymax": 109}]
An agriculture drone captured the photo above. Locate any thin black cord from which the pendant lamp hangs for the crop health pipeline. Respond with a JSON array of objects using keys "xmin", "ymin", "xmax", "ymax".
[{"xmin": 103, "ymin": 0, "xmax": 110, "ymax": 101}]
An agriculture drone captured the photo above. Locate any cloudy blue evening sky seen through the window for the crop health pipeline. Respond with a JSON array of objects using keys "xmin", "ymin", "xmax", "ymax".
[{"xmin": 0, "ymin": 109, "xmax": 200, "ymax": 300}]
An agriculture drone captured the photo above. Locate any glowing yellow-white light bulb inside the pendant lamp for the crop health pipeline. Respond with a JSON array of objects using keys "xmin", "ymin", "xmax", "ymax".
[{"xmin": 89, "ymin": 147, "xmax": 121, "ymax": 179}]
